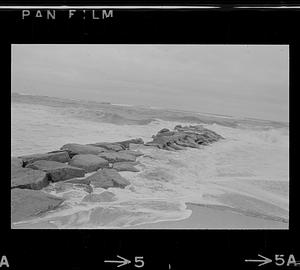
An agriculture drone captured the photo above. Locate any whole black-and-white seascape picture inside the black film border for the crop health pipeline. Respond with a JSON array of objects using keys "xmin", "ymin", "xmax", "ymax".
[{"xmin": 11, "ymin": 44, "xmax": 289, "ymax": 230}]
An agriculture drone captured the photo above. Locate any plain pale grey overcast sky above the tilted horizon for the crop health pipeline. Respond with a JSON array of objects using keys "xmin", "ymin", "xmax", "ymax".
[{"xmin": 12, "ymin": 45, "xmax": 289, "ymax": 121}]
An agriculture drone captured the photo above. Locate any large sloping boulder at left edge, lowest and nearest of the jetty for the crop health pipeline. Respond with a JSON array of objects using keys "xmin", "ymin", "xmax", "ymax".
[{"xmin": 11, "ymin": 188, "xmax": 64, "ymax": 222}]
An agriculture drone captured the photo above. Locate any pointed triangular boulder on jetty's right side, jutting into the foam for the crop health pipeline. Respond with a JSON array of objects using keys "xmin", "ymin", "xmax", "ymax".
[{"xmin": 87, "ymin": 168, "xmax": 130, "ymax": 188}]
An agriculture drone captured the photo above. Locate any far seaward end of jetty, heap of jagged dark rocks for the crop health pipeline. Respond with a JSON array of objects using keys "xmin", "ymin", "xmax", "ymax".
[{"xmin": 146, "ymin": 125, "xmax": 223, "ymax": 151}]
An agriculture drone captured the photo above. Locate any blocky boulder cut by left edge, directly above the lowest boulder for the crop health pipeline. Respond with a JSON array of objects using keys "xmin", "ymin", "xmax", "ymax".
[{"xmin": 10, "ymin": 167, "xmax": 49, "ymax": 190}]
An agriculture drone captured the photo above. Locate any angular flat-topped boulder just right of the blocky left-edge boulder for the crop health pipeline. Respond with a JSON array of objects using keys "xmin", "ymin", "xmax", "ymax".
[{"xmin": 26, "ymin": 160, "xmax": 85, "ymax": 182}]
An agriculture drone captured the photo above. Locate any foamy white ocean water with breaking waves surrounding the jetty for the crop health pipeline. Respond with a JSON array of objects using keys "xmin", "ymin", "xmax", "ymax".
[{"xmin": 11, "ymin": 96, "xmax": 289, "ymax": 228}]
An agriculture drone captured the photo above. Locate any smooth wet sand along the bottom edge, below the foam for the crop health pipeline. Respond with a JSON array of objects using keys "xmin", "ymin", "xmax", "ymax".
[{"xmin": 11, "ymin": 203, "xmax": 289, "ymax": 230}]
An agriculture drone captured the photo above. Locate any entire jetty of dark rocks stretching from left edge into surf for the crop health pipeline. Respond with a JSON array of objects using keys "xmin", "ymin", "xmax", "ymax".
[{"xmin": 11, "ymin": 125, "xmax": 223, "ymax": 225}]
